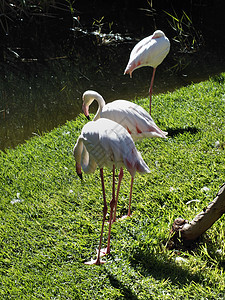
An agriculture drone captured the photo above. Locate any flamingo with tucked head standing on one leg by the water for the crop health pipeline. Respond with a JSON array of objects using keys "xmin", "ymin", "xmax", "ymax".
[{"xmin": 124, "ymin": 30, "xmax": 170, "ymax": 114}]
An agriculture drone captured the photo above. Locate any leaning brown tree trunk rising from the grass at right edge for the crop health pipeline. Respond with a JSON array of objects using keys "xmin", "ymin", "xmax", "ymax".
[{"xmin": 171, "ymin": 183, "xmax": 225, "ymax": 240}]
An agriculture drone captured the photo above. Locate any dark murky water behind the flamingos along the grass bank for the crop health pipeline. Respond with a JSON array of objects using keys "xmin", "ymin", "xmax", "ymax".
[{"xmin": 0, "ymin": 36, "xmax": 225, "ymax": 150}]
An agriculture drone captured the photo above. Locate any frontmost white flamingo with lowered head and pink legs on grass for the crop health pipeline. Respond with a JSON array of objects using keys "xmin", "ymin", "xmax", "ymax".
[{"xmin": 73, "ymin": 119, "xmax": 150, "ymax": 265}]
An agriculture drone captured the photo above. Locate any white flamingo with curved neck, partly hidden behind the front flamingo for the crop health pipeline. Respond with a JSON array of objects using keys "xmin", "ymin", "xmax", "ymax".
[{"xmin": 82, "ymin": 90, "xmax": 167, "ymax": 222}]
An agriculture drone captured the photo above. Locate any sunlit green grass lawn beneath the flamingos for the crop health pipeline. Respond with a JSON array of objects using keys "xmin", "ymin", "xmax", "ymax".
[{"xmin": 0, "ymin": 74, "xmax": 225, "ymax": 299}]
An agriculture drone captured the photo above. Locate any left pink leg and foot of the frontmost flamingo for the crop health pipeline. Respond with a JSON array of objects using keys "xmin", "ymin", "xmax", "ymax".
[{"xmin": 85, "ymin": 168, "xmax": 107, "ymax": 265}]
